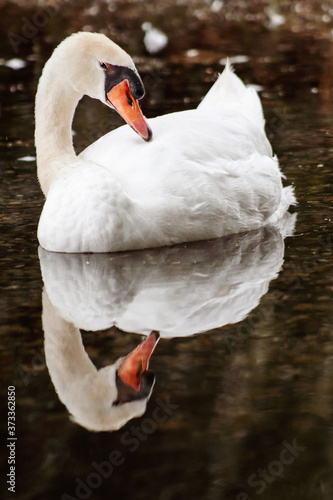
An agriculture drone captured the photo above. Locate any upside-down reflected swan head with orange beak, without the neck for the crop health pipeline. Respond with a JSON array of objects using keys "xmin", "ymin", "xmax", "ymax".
[{"xmin": 66, "ymin": 331, "xmax": 160, "ymax": 431}]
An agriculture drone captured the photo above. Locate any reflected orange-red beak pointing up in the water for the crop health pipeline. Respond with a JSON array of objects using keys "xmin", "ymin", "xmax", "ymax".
[{"xmin": 117, "ymin": 331, "xmax": 160, "ymax": 391}]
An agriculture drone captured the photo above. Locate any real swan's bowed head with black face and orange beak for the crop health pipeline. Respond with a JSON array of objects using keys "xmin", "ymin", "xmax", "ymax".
[{"xmin": 51, "ymin": 32, "xmax": 152, "ymax": 141}]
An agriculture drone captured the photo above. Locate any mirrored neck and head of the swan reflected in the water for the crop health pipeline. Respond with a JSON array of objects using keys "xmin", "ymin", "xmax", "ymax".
[{"xmin": 43, "ymin": 290, "xmax": 159, "ymax": 431}]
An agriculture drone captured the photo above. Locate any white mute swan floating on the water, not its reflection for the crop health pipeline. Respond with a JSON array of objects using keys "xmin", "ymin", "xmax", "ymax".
[{"xmin": 35, "ymin": 33, "xmax": 295, "ymax": 253}]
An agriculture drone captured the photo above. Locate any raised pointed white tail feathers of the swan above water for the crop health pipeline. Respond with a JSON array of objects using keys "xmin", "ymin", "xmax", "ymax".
[{"xmin": 198, "ymin": 61, "xmax": 265, "ymax": 129}]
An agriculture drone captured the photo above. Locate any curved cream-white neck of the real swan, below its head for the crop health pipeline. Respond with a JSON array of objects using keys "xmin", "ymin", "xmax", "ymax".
[{"xmin": 35, "ymin": 59, "xmax": 82, "ymax": 196}]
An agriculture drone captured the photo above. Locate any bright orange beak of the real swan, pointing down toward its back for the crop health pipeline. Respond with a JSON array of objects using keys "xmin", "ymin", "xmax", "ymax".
[{"xmin": 106, "ymin": 79, "xmax": 153, "ymax": 141}]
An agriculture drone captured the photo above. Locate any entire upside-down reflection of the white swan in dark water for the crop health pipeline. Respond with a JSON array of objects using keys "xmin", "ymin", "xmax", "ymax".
[{"xmin": 39, "ymin": 218, "xmax": 292, "ymax": 431}]
